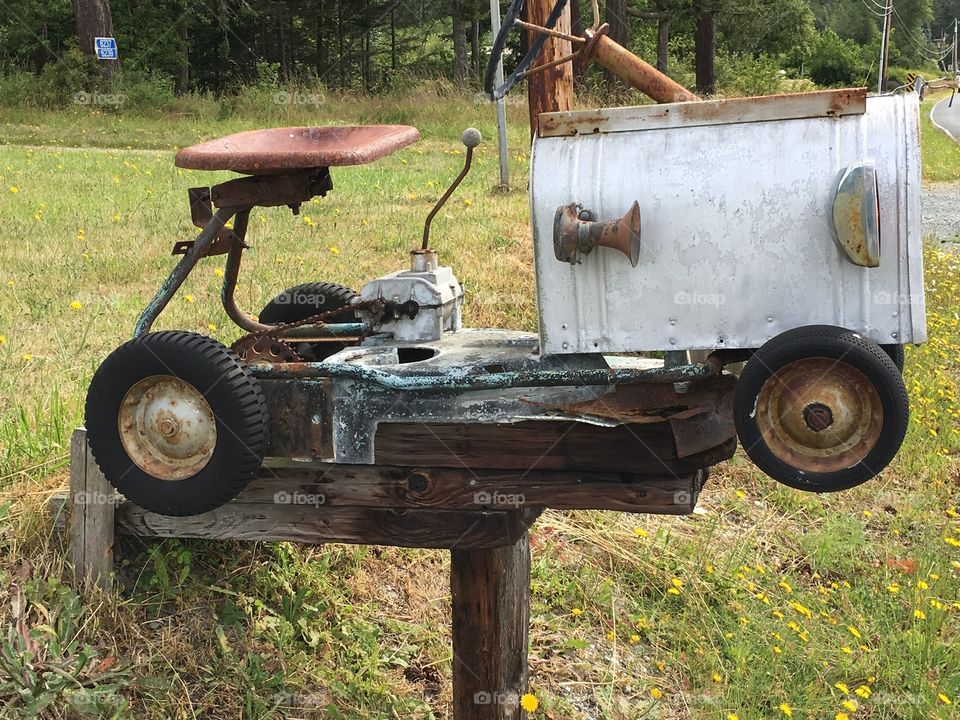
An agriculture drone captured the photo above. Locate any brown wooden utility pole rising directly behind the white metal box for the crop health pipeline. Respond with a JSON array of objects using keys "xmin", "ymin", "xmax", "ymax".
[{"xmin": 525, "ymin": 0, "xmax": 573, "ymax": 137}]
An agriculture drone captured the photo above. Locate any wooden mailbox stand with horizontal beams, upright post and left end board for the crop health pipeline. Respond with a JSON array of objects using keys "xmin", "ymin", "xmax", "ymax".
[{"xmin": 60, "ymin": 423, "xmax": 730, "ymax": 720}]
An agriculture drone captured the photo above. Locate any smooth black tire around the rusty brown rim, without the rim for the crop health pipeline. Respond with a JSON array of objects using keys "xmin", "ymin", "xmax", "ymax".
[{"xmin": 733, "ymin": 325, "xmax": 910, "ymax": 492}]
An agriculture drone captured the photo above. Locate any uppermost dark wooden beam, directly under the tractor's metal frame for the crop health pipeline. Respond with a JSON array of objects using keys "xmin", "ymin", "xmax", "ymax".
[{"xmin": 375, "ymin": 420, "xmax": 733, "ymax": 476}]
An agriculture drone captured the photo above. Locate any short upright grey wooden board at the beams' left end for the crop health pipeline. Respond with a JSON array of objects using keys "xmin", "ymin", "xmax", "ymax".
[{"xmin": 70, "ymin": 428, "xmax": 116, "ymax": 589}]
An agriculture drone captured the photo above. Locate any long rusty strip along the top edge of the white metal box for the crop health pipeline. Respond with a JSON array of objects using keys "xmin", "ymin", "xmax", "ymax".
[{"xmin": 539, "ymin": 88, "xmax": 867, "ymax": 137}]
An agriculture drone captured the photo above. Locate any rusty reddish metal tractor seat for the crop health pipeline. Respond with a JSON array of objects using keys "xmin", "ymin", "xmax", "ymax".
[{"xmin": 174, "ymin": 125, "xmax": 420, "ymax": 175}]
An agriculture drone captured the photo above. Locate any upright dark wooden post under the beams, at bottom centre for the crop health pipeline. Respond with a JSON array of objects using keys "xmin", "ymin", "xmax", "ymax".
[{"xmin": 450, "ymin": 533, "xmax": 530, "ymax": 720}]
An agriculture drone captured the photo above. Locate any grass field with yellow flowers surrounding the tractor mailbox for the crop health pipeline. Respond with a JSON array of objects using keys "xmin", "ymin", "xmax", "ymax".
[{"xmin": 0, "ymin": 95, "xmax": 960, "ymax": 720}]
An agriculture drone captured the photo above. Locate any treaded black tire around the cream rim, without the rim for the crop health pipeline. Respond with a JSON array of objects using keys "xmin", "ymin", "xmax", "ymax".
[{"xmin": 86, "ymin": 331, "xmax": 269, "ymax": 516}]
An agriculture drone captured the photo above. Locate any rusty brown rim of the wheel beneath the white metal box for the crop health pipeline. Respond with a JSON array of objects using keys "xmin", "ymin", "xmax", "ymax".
[{"xmin": 755, "ymin": 358, "xmax": 883, "ymax": 473}]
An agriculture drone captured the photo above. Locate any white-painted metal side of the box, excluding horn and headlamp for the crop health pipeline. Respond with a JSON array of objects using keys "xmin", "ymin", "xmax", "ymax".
[{"xmin": 531, "ymin": 94, "xmax": 926, "ymax": 353}]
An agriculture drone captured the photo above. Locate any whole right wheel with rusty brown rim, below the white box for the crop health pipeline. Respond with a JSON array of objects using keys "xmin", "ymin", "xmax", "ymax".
[{"xmin": 734, "ymin": 325, "xmax": 910, "ymax": 492}]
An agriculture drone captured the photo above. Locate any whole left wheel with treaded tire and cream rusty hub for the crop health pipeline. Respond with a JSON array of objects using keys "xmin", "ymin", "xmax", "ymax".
[{"xmin": 86, "ymin": 331, "xmax": 267, "ymax": 515}]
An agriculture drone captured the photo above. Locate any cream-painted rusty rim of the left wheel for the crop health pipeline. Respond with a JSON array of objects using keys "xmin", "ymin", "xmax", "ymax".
[{"xmin": 118, "ymin": 375, "xmax": 217, "ymax": 480}]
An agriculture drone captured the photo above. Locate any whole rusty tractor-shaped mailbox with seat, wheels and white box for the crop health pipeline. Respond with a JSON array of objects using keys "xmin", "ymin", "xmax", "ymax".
[{"xmin": 86, "ymin": 0, "xmax": 925, "ymax": 515}]
